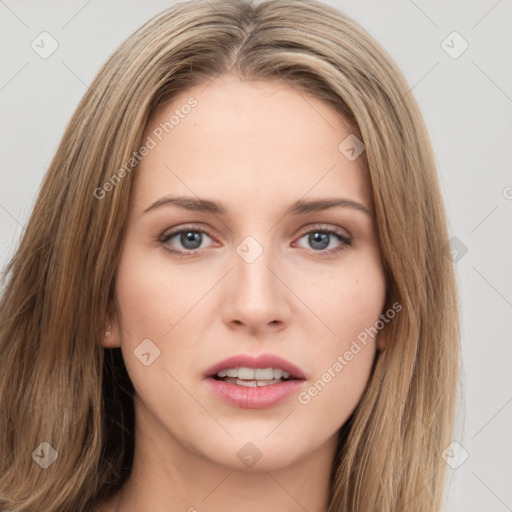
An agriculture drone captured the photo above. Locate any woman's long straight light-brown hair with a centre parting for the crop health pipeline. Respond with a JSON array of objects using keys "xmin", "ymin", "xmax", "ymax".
[{"xmin": 0, "ymin": 0, "xmax": 460, "ymax": 512}]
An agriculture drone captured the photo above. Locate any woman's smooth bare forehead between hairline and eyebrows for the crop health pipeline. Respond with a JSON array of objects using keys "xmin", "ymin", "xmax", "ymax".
[{"xmin": 129, "ymin": 77, "xmax": 368, "ymax": 215}]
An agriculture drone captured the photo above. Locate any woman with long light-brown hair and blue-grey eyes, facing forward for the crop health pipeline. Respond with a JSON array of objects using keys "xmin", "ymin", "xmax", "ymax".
[{"xmin": 0, "ymin": 0, "xmax": 459, "ymax": 512}]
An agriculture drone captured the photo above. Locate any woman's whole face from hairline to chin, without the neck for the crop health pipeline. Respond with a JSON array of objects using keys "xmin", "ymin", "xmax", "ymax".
[{"xmin": 105, "ymin": 77, "xmax": 386, "ymax": 470}]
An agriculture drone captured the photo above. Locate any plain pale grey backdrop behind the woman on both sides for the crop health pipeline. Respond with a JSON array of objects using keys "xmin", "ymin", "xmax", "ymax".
[{"xmin": 0, "ymin": 0, "xmax": 512, "ymax": 512}]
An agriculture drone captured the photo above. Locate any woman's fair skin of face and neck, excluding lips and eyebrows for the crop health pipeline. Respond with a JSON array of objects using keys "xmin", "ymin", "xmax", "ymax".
[{"xmin": 98, "ymin": 76, "xmax": 386, "ymax": 512}]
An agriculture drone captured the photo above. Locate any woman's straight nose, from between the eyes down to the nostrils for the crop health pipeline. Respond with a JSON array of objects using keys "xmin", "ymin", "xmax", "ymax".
[{"xmin": 222, "ymin": 242, "xmax": 291, "ymax": 334}]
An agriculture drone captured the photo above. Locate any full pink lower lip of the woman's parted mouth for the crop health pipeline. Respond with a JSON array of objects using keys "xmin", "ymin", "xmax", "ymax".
[{"xmin": 206, "ymin": 377, "xmax": 305, "ymax": 409}]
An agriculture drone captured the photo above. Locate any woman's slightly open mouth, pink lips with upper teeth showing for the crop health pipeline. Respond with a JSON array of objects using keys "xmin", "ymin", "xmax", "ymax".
[{"xmin": 203, "ymin": 354, "xmax": 306, "ymax": 409}]
